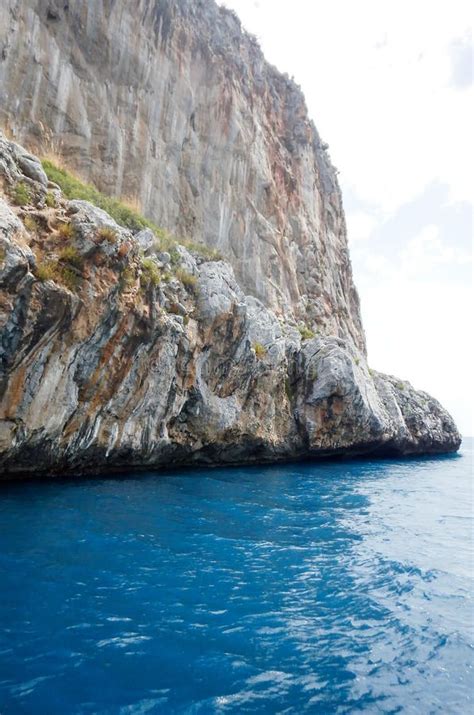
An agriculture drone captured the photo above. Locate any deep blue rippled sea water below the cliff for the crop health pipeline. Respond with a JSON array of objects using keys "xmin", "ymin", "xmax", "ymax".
[{"xmin": 0, "ymin": 442, "xmax": 474, "ymax": 715}]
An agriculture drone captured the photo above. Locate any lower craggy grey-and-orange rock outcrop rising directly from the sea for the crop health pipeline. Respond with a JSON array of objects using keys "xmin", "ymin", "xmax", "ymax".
[{"xmin": 0, "ymin": 137, "xmax": 460, "ymax": 478}]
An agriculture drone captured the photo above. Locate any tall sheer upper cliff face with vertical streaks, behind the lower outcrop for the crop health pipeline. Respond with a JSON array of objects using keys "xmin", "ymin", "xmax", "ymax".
[{"xmin": 0, "ymin": 0, "xmax": 365, "ymax": 352}]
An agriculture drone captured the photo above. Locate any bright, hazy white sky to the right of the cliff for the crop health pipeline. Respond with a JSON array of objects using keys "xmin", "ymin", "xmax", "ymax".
[{"xmin": 221, "ymin": 0, "xmax": 474, "ymax": 435}]
